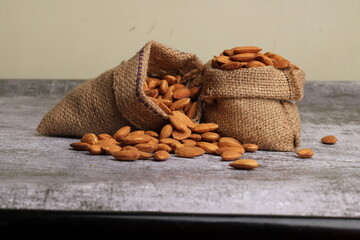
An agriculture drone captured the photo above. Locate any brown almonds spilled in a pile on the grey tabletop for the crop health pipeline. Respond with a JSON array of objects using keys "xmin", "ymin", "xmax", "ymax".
[{"xmin": 70, "ymin": 110, "xmax": 259, "ymax": 169}]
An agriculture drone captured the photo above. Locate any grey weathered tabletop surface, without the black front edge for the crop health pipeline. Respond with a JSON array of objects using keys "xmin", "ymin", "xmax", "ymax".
[{"xmin": 0, "ymin": 80, "xmax": 360, "ymax": 218}]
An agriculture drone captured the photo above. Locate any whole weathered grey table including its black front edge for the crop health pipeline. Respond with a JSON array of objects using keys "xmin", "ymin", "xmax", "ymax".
[{"xmin": 0, "ymin": 80, "xmax": 360, "ymax": 238}]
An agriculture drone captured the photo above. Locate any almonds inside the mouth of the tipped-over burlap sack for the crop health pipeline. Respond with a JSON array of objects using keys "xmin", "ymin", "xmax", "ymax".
[{"xmin": 143, "ymin": 75, "xmax": 200, "ymax": 119}]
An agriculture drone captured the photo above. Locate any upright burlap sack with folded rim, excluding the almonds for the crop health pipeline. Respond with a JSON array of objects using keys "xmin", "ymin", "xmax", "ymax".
[{"xmin": 202, "ymin": 62, "xmax": 305, "ymax": 151}]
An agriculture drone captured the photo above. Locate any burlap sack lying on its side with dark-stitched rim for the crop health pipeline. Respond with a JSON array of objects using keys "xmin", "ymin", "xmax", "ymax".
[{"xmin": 37, "ymin": 41, "xmax": 203, "ymax": 137}]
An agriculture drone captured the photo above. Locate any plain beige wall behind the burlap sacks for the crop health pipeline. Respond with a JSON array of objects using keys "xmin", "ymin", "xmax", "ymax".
[{"xmin": 0, "ymin": 0, "xmax": 360, "ymax": 80}]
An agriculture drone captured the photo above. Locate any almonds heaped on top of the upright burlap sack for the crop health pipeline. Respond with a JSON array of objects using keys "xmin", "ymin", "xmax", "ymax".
[{"xmin": 211, "ymin": 46, "xmax": 299, "ymax": 70}]
